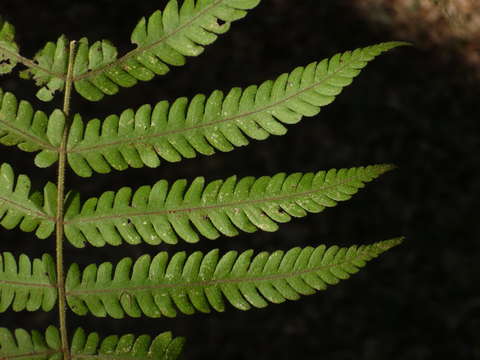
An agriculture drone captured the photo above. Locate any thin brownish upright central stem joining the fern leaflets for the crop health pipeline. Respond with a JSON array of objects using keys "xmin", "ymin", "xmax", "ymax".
[{"xmin": 55, "ymin": 41, "xmax": 76, "ymax": 360}]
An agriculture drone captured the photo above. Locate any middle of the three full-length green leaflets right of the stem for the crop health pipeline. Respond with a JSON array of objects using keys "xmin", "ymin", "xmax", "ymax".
[{"xmin": 64, "ymin": 165, "xmax": 392, "ymax": 247}]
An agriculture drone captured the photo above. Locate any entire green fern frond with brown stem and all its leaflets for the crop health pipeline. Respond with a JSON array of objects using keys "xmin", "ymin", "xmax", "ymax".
[{"xmin": 0, "ymin": 0, "xmax": 403, "ymax": 360}]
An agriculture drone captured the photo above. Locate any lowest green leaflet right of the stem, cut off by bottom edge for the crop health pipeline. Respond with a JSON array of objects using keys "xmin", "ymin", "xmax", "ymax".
[{"xmin": 71, "ymin": 328, "xmax": 185, "ymax": 360}]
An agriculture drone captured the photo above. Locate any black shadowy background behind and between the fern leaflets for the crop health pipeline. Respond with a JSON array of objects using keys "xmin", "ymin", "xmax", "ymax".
[{"xmin": 0, "ymin": 0, "xmax": 480, "ymax": 360}]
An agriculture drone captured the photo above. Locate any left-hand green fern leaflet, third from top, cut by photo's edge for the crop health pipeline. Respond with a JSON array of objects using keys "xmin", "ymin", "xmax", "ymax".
[{"xmin": 0, "ymin": 163, "xmax": 57, "ymax": 239}]
